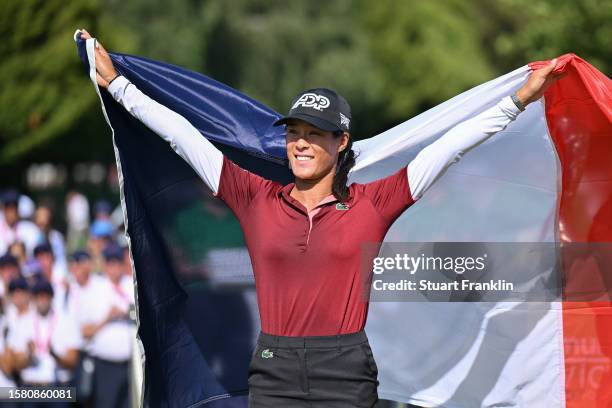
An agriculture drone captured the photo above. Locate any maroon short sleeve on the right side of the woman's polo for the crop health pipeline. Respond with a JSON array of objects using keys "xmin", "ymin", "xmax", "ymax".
[{"xmin": 361, "ymin": 166, "xmax": 415, "ymax": 224}]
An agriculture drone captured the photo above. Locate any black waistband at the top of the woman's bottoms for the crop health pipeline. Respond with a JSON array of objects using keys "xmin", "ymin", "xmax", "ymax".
[{"xmin": 257, "ymin": 330, "xmax": 368, "ymax": 348}]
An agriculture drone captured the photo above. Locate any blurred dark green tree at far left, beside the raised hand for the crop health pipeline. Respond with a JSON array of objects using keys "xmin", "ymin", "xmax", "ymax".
[{"xmin": 0, "ymin": 0, "xmax": 129, "ymax": 163}]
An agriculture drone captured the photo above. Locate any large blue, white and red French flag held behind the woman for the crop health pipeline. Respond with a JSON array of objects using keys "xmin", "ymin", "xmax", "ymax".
[{"xmin": 75, "ymin": 31, "xmax": 612, "ymax": 408}]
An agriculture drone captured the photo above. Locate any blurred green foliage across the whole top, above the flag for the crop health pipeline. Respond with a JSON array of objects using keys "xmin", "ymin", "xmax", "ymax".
[{"xmin": 0, "ymin": 0, "xmax": 612, "ymax": 163}]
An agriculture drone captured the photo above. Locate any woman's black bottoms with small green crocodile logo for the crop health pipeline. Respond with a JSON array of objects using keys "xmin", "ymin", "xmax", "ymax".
[{"xmin": 249, "ymin": 331, "xmax": 378, "ymax": 408}]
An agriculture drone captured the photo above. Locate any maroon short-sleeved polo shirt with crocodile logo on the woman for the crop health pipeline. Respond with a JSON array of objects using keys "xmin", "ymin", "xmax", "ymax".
[{"xmin": 217, "ymin": 157, "xmax": 414, "ymax": 336}]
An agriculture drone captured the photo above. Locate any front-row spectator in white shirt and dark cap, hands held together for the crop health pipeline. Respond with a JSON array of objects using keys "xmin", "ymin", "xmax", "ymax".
[{"xmin": 7, "ymin": 279, "xmax": 81, "ymax": 407}]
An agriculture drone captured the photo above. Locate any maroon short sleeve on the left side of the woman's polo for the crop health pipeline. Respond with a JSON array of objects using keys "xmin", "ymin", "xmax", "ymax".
[{"xmin": 216, "ymin": 156, "xmax": 274, "ymax": 220}]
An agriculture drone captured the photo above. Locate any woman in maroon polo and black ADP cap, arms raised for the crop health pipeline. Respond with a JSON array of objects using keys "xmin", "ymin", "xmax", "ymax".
[{"xmin": 82, "ymin": 31, "xmax": 557, "ymax": 407}]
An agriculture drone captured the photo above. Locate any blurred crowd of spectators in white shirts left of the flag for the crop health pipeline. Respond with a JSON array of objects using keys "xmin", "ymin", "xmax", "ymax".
[{"xmin": 0, "ymin": 189, "xmax": 136, "ymax": 408}]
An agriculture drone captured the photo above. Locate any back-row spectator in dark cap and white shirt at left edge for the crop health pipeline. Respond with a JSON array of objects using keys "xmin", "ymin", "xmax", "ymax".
[{"xmin": 0, "ymin": 190, "xmax": 41, "ymax": 254}]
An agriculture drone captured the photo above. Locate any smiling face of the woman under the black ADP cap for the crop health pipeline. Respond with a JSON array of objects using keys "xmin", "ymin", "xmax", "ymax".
[{"xmin": 286, "ymin": 119, "xmax": 348, "ymax": 180}]
